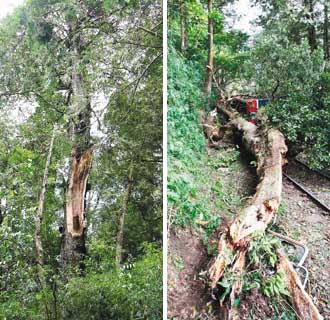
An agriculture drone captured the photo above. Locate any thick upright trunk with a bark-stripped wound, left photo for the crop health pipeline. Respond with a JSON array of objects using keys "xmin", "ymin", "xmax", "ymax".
[{"xmin": 61, "ymin": 31, "xmax": 92, "ymax": 270}]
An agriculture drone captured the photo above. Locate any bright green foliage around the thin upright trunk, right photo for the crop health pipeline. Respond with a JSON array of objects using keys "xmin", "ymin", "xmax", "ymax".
[{"xmin": 168, "ymin": 0, "xmax": 249, "ymax": 94}]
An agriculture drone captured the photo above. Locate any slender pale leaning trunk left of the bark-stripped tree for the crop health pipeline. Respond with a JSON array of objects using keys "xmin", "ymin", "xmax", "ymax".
[{"xmin": 35, "ymin": 126, "xmax": 56, "ymax": 272}]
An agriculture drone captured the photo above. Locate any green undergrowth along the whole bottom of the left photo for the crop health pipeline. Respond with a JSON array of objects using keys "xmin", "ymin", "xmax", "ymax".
[{"xmin": 0, "ymin": 243, "xmax": 162, "ymax": 320}]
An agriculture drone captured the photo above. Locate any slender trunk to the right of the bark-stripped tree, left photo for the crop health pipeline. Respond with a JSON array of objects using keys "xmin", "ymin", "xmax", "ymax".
[{"xmin": 116, "ymin": 165, "xmax": 133, "ymax": 268}]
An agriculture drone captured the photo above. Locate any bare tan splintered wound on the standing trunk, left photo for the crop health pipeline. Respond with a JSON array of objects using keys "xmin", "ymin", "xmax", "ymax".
[{"xmin": 66, "ymin": 149, "xmax": 92, "ymax": 237}]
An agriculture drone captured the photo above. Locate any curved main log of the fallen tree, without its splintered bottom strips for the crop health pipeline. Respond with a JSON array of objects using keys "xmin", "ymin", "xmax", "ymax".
[{"xmin": 209, "ymin": 104, "xmax": 287, "ymax": 288}]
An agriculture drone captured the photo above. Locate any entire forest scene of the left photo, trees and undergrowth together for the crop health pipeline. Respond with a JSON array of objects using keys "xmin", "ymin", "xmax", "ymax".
[{"xmin": 0, "ymin": 0, "xmax": 163, "ymax": 320}]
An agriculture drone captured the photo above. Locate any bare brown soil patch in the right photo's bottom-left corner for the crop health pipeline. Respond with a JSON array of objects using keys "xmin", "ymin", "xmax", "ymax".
[{"xmin": 167, "ymin": 228, "xmax": 211, "ymax": 319}]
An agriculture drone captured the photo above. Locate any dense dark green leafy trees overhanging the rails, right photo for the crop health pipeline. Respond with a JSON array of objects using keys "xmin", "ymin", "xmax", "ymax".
[{"xmin": 245, "ymin": 1, "xmax": 330, "ymax": 169}]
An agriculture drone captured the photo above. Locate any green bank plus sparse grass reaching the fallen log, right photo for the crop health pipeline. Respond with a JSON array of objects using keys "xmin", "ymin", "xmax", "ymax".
[{"xmin": 168, "ymin": 48, "xmax": 241, "ymax": 240}]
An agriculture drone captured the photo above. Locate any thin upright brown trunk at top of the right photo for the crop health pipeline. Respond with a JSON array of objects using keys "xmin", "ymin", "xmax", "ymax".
[{"xmin": 205, "ymin": 0, "xmax": 214, "ymax": 96}]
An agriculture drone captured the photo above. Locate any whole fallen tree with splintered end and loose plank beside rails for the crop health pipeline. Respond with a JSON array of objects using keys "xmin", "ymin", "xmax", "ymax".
[{"xmin": 205, "ymin": 101, "xmax": 322, "ymax": 320}]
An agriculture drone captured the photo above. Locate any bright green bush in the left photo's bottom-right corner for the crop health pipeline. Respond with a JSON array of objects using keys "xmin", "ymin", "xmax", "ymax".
[{"xmin": 60, "ymin": 245, "xmax": 162, "ymax": 320}]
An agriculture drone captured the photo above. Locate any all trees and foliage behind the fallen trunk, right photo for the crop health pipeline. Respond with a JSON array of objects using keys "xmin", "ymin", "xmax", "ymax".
[{"xmin": 169, "ymin": 0, "xmax": 330, "ymax": 169}]
